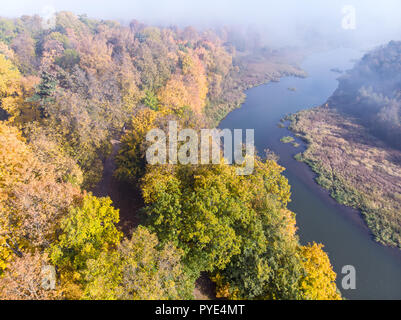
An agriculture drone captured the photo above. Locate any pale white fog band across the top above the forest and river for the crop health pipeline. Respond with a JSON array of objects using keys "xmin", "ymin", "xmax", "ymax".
[{"xmin": 0, "ymin": 0, "xmax": 401, "ymax": 47}]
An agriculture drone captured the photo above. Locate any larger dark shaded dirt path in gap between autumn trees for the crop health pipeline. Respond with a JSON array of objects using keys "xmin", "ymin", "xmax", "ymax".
[{"xmin": 93, "ymin": 140, "xmax": 143, "ymax": 235}]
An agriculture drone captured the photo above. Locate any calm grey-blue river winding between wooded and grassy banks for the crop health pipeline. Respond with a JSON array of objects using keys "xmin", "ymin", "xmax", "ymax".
[{"xmin": 219, "ymin": 49, "xmax": 401, "ymax": 299}]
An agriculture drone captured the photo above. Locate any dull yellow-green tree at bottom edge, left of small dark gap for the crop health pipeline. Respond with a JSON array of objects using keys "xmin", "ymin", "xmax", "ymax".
[{"xmin": 84, "ymin": 226, "xmax": 194, "ymax": 300}]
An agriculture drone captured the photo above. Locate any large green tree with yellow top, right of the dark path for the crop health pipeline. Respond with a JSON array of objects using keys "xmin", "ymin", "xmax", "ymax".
[{"xmin": 142, "ymin": 166, "xmax": 239, "ymax": 275}]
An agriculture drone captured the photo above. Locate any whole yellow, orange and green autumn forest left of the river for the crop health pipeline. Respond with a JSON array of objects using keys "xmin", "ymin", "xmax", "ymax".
[{"xmin": 0, "ymin": 12, "xmax": 341, "ymax": 299}]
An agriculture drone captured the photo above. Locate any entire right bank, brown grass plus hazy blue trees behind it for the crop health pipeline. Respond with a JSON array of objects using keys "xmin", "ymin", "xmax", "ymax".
[{"xmin": 289, "ymin": 41, "xmax": 401, "ymax": 248}]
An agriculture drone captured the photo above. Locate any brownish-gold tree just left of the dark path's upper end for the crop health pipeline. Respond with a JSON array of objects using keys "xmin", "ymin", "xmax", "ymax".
[{"xmin": 40, "ymin": 90, "xmax": 110, "ymax": 188}]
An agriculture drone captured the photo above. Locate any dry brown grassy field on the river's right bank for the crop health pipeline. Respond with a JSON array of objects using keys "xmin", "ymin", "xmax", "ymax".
[{"xmin": 290, "ymin": 106, "xmax": 401, "ymax": 248}]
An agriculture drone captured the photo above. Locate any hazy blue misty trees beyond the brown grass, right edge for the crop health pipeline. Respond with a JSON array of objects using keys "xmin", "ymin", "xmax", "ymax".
[{"xmin": 330, "ymin": 41, "xmax": 401, "ymax": 149}]
